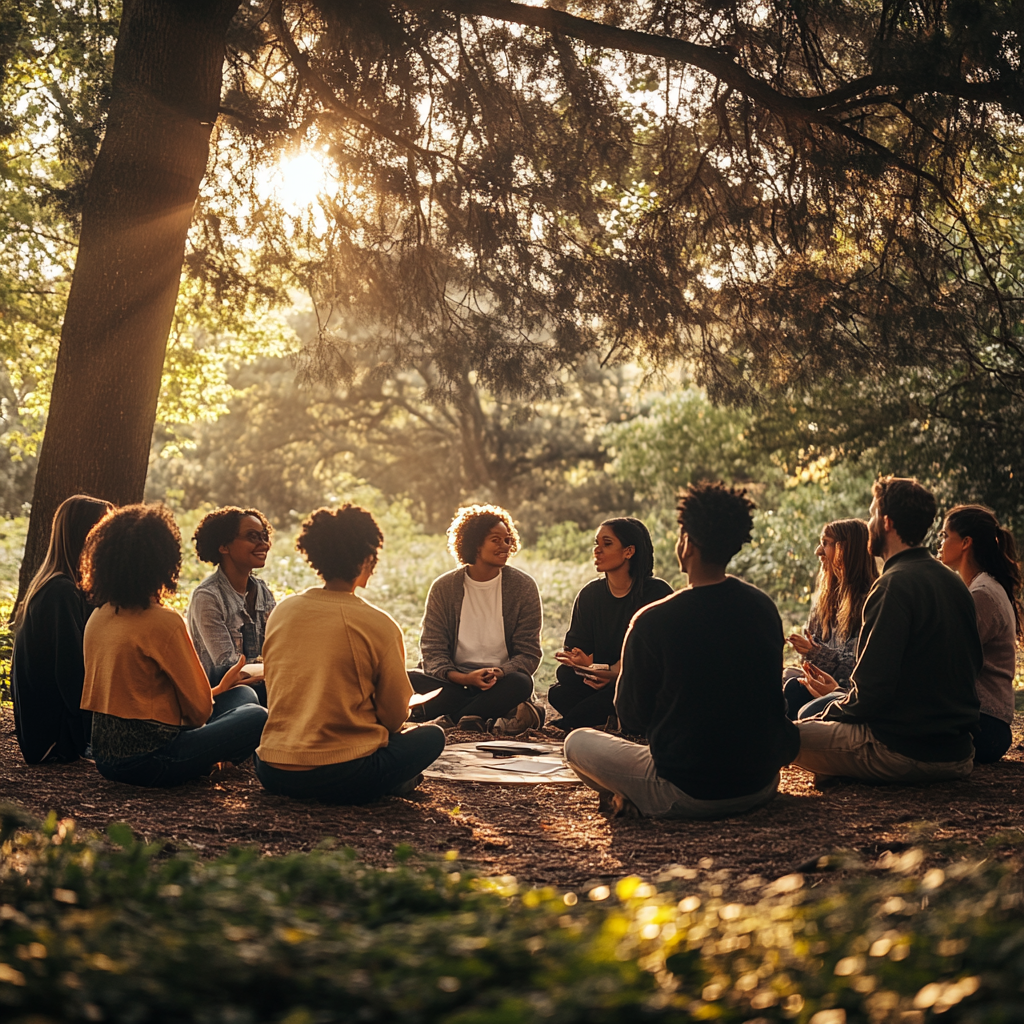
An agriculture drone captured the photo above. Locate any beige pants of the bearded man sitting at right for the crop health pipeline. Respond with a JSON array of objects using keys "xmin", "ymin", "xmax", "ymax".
[{"xmin": 793, "ymin": 721, "xmax": 974, "ymax": 782}]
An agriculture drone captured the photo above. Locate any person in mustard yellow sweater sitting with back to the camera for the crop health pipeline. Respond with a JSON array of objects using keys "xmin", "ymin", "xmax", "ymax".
[{"xmin": 256, "ymin": 505, "xmax": 444, "ymax": 804}]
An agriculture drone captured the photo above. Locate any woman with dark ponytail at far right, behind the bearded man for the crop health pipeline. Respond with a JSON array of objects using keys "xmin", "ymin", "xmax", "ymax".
[{"xmin": 939, "ymin": 505, "xmax": 1024, "ymax": 765}]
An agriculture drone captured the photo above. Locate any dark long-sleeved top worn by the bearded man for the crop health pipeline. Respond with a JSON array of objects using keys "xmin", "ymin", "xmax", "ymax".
[{"xmin": 826, "ymin": 548, "xmax": 983, "ymax": 762}]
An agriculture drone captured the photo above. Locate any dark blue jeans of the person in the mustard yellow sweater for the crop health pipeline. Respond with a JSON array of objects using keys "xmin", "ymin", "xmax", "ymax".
[{"xmin": 255, "ymin": 725, "xmax": 444, "ymax": 804}]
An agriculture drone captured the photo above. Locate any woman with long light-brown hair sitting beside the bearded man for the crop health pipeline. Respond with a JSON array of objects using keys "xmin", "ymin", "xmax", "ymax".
[{"xmin": 784, "ymin": 519, "xmax": 879, "ymax": 719}]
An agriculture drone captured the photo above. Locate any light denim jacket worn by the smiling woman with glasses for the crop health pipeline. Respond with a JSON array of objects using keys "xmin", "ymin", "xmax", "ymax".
[{"xmin": 186, "ymin": 565, "xmax": 276, "ymax": 676}]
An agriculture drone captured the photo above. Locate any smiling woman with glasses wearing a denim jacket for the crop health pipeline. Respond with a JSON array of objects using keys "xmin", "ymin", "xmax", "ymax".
[{"xmin": 187, "ymin": 506, "xmax": 275, "ymax": 707}]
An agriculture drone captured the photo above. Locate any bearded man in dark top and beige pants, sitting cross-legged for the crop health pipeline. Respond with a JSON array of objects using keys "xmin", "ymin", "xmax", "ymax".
[{"xmin": 794, "ymin": 476, "xmax": 982, "ymax": 782}]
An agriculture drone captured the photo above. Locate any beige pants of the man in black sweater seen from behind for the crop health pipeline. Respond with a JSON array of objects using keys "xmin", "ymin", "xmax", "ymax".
[{"xmin": 565, "ymin": 729, "xmax": 778, "ymax": 818}]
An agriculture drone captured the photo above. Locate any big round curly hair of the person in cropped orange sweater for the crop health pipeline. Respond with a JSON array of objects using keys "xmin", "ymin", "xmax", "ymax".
[{"xmin": 82, "ymin": 505, "xmax": 181, "ymax": 608}]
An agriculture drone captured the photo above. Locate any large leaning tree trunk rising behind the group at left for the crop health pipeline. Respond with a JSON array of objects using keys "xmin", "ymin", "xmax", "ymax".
[{"xmin": 20, "ymin": 0, "xmax": 240, "ymax": 593}]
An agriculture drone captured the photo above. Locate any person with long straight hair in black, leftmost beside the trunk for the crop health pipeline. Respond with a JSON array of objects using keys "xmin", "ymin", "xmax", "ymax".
[{"xmin": 10, "ymin": 495, "xmax": 113, "ymax": 765}]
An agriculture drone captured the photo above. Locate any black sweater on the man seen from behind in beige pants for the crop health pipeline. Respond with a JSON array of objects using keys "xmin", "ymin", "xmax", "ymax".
[{"xmin": 615, "ymin": 577, "xmax": 800, "ymax": 800}]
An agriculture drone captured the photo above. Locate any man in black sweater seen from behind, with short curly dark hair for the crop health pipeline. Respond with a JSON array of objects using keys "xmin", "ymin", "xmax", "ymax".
[{"xmin": 564, "ymin": 483, "xmax": 800, "ymax": 818}]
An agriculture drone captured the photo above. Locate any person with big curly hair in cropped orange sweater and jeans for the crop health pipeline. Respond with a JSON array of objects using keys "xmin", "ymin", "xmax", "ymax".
[{"xmin": 82, "ymin": 505, "xmax": 266, "ymax": 786}]
